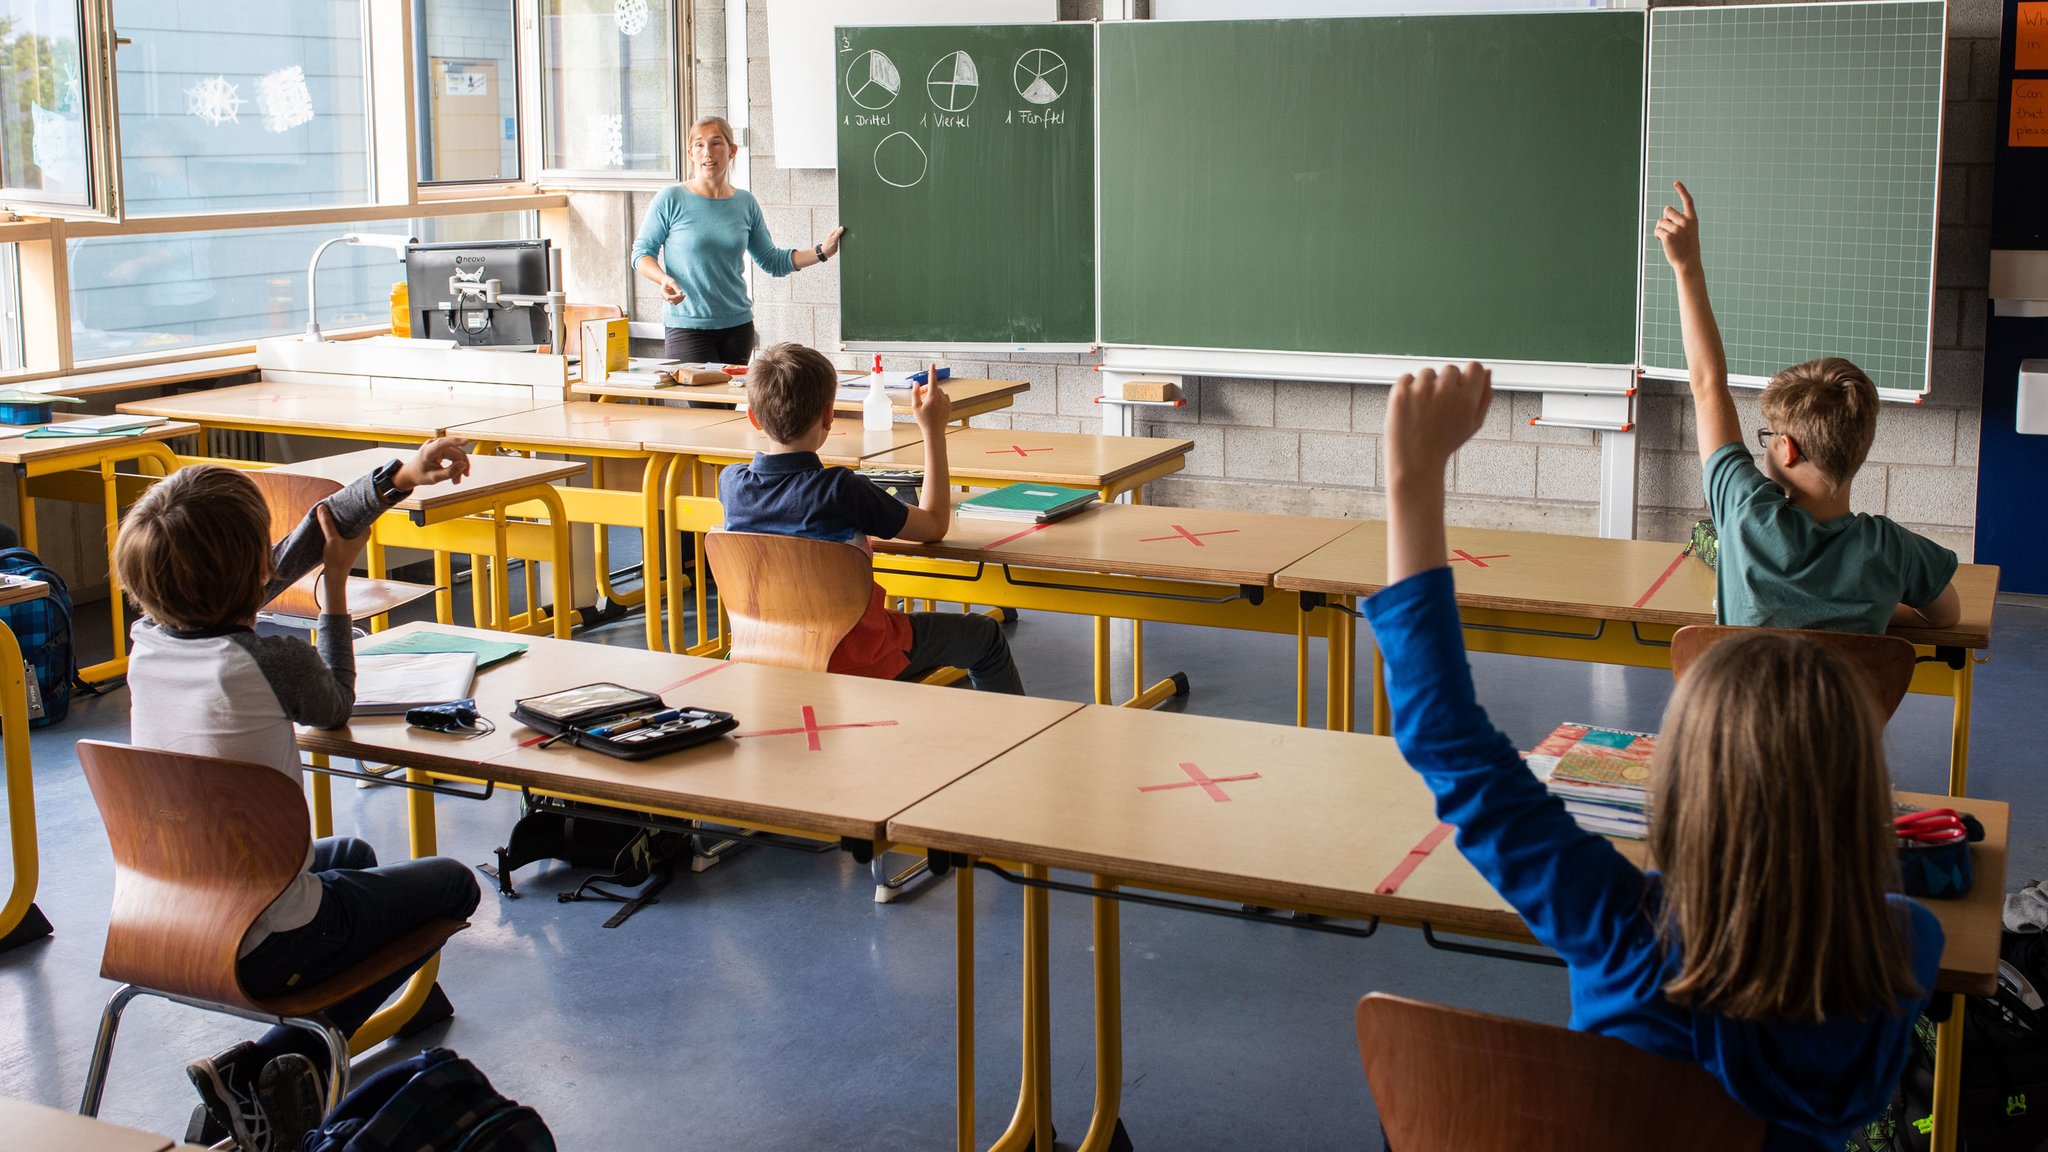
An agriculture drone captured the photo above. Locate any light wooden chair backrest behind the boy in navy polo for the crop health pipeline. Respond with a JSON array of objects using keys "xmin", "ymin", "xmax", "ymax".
[{"xmin": 705, "ymin": 531, "xmax": 874, "ymax": 672}]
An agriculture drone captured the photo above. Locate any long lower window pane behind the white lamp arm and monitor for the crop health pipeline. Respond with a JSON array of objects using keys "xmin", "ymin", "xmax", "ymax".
[{"xmin": 70, "ymin": 213, "xmax": 535, "ymax": 361}]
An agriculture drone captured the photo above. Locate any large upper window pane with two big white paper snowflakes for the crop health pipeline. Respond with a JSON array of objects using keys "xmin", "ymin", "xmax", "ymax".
[{"xmin": 108, "ymin": 0, "xmax": 371, "ymax": 213}]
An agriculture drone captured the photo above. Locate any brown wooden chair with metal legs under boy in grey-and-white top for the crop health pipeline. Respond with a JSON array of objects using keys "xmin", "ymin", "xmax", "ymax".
[{"xmin": 78, "ymin": 740, "xmax": 469, "ymax": 1115}]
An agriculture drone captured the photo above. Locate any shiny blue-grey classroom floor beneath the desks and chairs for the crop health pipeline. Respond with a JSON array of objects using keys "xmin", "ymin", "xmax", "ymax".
[{"xmin": 0, "ymin": 553, "xmax": 2048, "ymax": 1152}]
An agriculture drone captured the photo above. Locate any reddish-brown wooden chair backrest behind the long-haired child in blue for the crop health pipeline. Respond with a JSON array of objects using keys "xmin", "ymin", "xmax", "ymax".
[{"xmin": 1358, "ymin": 992, "xmax": 1763, "ymax": 1152}]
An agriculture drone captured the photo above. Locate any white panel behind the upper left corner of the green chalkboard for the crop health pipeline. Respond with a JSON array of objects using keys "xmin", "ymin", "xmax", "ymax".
[{"xmin": 770, "ymin": 0, "xmax": 1059, "ymax": 168}]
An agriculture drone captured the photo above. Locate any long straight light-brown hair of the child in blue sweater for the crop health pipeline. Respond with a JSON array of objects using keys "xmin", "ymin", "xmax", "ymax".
[{"xmin": 1651, "ymin": 631, "xmax": 1921, "ymax": 1023}]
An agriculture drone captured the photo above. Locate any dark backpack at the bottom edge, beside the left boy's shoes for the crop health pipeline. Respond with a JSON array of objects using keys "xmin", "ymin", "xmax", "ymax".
[{"xmin": 303, "ymin": 1047, "xmax": 555, "ymax": 1152}]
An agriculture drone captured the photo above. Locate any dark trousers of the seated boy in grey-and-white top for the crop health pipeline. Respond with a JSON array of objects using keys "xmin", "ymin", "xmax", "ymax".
[{"xmin": 238, "ymin": 836, "xmax": 479, "ymax": 1070}]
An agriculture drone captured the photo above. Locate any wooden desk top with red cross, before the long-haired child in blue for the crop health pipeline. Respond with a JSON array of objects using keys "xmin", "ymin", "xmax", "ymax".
[{"xmin": 889, "ymin": 705, "xmax": 2009, "ymax": 994}]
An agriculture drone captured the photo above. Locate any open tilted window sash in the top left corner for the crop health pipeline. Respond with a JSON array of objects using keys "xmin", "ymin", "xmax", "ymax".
[{"xmin": 0, "ymin": 0, "xmax": 119, "ymax": 217}]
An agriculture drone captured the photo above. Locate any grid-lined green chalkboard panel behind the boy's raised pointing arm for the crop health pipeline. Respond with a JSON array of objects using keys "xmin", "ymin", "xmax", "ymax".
[{"xmin": 1642, "ymin": 0, "xmax": 1944, "ymax": 392}]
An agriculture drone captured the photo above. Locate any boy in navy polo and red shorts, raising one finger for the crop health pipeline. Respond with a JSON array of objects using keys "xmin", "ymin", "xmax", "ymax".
[{"xmin": 719, "ymin": 342, "xmax": 1024, "ymax": 695}]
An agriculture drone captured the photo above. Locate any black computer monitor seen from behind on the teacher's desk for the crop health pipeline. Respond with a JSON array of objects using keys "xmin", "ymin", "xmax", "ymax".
[{"xmin": 406, "ymin": 240, "xmax": 553, "ymax": 348}]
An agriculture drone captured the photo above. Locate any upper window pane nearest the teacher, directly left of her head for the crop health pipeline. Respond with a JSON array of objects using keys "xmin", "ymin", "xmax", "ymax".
[{"xmin": 541, "ymin": 0, "xmax": 684, "ymax": 187}]
